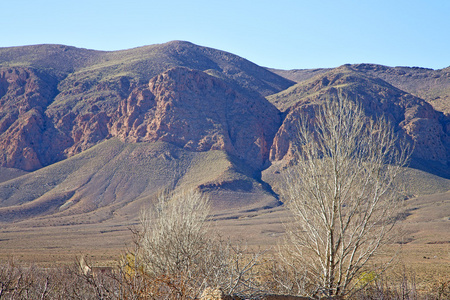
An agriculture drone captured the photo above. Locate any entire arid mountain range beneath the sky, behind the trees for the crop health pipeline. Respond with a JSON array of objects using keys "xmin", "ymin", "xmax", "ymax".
[{"xmin": 0, "ymin": 41, "xmax": 450, "ymax": 226}]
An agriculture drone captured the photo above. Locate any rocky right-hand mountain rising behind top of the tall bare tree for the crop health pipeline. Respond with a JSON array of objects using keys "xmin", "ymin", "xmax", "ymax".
[{"xmin": 270, "ymin": 66, "xmax": 450, "ymax": 163}]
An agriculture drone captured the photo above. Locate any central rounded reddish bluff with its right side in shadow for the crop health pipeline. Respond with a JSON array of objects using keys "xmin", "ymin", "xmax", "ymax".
[{"xmin": 109, "ymin": 68, "xmax": 281, "ymax": 168}]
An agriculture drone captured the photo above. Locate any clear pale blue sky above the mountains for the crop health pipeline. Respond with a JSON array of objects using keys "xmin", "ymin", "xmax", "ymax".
[{"xmin": 0, "ymin": 0, "xmax": 450, "ymax": 69}]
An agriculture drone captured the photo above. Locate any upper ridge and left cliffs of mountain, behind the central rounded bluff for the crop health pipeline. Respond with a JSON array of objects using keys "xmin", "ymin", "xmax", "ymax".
[{"xmin": 0, "ymin": 41, "xmax": 292, "ymax": 171}]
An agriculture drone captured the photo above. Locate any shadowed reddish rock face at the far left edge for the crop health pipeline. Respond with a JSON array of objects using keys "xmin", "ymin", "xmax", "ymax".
[{"xmin": 0, "ymin": 68, "xmax": 55, "ymax": 170}]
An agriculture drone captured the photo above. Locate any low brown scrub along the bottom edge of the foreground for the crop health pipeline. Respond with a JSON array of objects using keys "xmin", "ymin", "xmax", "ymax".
[{"xmin": 0, "ymin": 250, "xmax": 450, "ymax": 300}]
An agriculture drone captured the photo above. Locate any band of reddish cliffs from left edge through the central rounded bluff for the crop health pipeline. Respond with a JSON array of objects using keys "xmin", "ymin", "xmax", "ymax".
[{"xmin": 0, "ymin": 67, "xmax": 281, "ymax": 171}]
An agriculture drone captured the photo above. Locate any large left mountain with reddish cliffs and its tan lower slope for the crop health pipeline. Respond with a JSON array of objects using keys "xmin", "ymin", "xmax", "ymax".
[{"xmin": 0, "ymin": 41, "xmax": 292, "ymax": 221}]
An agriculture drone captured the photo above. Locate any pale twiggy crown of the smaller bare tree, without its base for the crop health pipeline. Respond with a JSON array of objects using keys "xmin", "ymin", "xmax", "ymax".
[{"xmin": 140, "ymin": 191, "xmax": 210, "ymax": 273}]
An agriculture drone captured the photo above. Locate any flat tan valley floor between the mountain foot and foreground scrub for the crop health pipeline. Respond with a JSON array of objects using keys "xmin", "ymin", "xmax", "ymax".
[{"xmin": 0, "ymin": 192, "xmax": 450, "ymax": 284}]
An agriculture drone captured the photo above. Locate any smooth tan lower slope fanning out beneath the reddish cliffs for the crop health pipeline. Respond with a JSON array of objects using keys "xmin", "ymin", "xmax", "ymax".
[{"xmin": 0, "ymin": 139, "xmax": 277, "ymax": 226}]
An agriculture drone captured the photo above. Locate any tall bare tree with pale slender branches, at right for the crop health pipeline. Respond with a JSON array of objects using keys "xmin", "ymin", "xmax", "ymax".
[{"xmin": 282, "ymin": 97, "xmax": 410, "ymax": 298}]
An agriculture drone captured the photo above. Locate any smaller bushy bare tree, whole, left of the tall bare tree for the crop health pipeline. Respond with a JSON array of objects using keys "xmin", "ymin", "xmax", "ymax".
[{"xmin": 135, "ymin": 191, "xmax": 212, "ymax": 299}]
